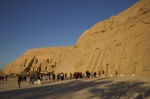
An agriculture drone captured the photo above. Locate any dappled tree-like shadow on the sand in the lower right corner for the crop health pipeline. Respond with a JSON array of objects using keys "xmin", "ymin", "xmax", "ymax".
[{"xmin": 89, "ymin": 81, "xmax": 150, "ymax": 99}]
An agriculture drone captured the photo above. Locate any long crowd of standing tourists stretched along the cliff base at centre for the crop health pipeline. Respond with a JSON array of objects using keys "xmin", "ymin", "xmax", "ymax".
[{"xmin": 14, "ymin": 70, "xmax": 104, "ymax": 87}]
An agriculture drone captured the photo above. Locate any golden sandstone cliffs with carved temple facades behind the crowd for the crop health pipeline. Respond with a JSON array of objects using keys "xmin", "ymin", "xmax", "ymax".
[{"xmin": 4, "ymin": 0, "xmax": 150, "ymax": 75}]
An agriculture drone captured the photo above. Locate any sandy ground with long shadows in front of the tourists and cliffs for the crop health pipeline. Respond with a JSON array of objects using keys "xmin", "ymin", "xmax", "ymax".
[{"xmin": 0, "ymin": 76, "xmax": 150, "ymax": 99}]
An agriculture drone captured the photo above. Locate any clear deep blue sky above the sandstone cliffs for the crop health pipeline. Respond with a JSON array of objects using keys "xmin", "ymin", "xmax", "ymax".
[{"xmin": 0, "ymin": 0, "xmax": 139, "ymax": 69}]
